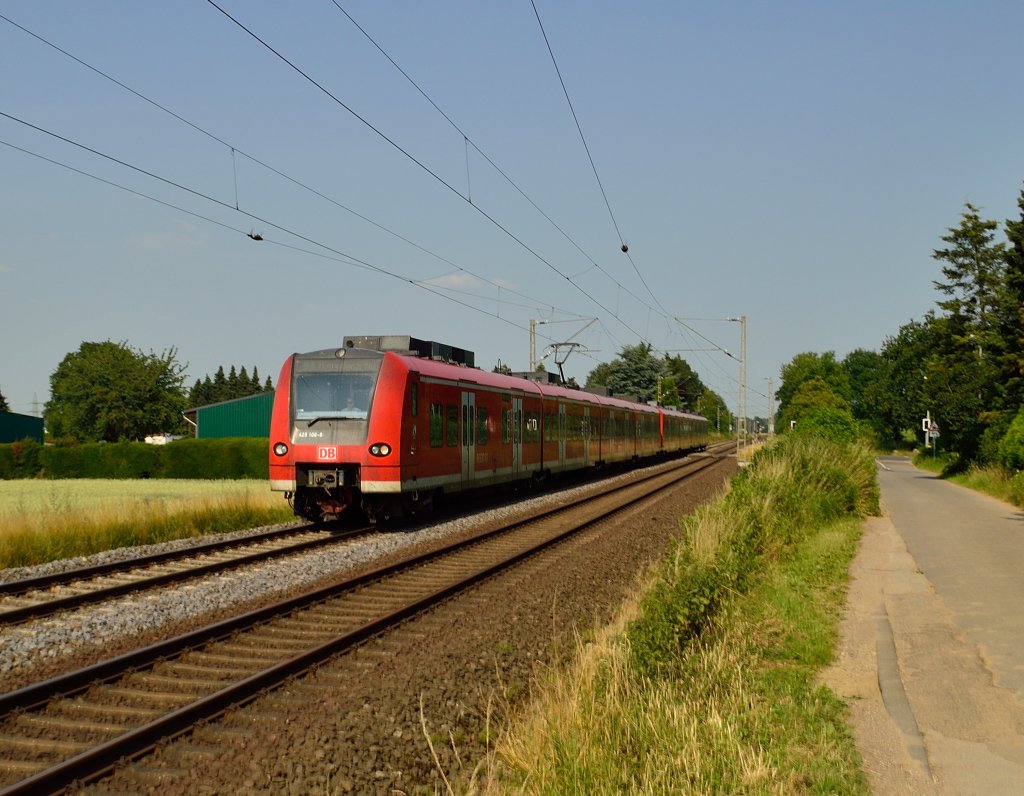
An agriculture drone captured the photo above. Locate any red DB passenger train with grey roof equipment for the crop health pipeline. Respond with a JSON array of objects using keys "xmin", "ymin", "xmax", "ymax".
[{"xmin": 269, "ymin": 336, "xmax": 708, "ymax": 521}]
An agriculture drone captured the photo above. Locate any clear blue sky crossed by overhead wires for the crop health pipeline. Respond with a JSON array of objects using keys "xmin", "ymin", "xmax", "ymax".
[{"xmin": 0, "ymin": 0, "xmax": 1024, "ymax": 422}]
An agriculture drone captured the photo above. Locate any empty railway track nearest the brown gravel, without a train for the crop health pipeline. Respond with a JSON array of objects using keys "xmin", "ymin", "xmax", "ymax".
[{"xmin": 0, "ymin": 450, "xmax": 714, "ymax": 793}]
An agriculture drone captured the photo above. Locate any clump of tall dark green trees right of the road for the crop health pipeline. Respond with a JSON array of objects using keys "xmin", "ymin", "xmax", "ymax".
[{"xmin": 794, "ymin": 191, "xmax": 1024, "ymax": 458}]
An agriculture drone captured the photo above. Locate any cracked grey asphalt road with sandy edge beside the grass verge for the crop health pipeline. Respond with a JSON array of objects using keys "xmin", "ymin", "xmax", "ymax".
[{"xmin": 826, "ymin": 457, "xmax": 1024, "ymax": 796}]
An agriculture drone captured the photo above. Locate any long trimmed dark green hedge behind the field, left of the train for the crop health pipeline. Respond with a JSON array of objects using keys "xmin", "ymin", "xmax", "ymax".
[{"xmin": 0, "ymin": 437, "xmax": 269, "ymax": 479}]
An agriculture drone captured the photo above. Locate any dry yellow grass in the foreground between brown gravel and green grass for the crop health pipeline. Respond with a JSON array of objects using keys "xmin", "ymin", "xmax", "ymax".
[{"xmin": 479, "ymin": 581, "xmax": 793, "ymax": 796}]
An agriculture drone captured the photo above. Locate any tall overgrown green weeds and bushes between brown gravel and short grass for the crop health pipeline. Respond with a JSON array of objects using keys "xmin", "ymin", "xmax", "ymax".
[{"xmin": 628, "ymin": 434, "xmax": 881, "ymax": 675}]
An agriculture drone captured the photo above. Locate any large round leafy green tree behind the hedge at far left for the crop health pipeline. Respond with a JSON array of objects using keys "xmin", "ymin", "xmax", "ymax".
[{"xmin": 45, "ymin": 340, "xmax": 185, "ymax": 443}]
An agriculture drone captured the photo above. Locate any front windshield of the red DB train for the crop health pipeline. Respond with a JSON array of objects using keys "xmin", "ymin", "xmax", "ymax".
[{"xmin": 293, "ymin": 357, "xmax": 381, "ymax": 424}]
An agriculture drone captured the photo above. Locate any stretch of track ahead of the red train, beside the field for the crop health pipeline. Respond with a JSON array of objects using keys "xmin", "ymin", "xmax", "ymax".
[{"xmin": 0, "ymin": 525, "xmax": 372, "ymax": 625}]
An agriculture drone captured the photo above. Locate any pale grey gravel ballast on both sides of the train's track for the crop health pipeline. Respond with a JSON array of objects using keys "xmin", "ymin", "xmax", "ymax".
[{"xmin": 0, "ymin": 471, "xmax": 671, "ymax": 692}]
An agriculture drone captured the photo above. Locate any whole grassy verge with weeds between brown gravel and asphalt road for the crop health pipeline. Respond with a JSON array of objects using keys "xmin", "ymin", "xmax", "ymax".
[{"xmin": 483, "ymin": 439, "xmax": 879, "ymax": 793}]
